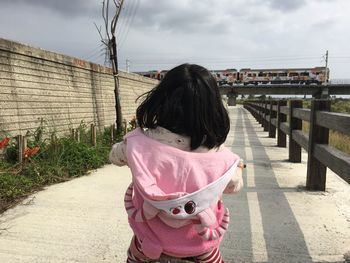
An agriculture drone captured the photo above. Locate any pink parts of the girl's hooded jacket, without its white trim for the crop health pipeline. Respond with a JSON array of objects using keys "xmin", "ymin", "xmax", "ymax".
[{"xmin": 121, "ymin": 128, "xmax": 239, "ymax": 259}]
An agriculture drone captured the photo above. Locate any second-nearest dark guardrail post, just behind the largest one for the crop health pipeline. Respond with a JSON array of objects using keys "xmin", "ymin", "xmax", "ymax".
[{"xmin": 289, "ymin": 100, "xmax": 303, "ymax": 163}]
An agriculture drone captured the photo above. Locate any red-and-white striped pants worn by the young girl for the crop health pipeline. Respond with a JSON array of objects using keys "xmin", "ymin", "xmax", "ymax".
[{"xmin": 126, "ymin": 236, "xmax": 224, "ymax": 263}]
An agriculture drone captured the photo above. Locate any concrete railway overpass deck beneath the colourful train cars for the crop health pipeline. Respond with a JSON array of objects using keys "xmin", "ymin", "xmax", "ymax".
[{"xmin": 219, "ymin": 84, "xmax": 350, "ymax": 106}]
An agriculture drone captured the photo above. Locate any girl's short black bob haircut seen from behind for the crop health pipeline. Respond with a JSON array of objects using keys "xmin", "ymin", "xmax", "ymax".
[{"xmin": 136, "ymin": 64, "xmax": 230, "ymax": 150}]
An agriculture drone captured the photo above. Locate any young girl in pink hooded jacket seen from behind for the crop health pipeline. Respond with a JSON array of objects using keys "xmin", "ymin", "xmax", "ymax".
[{"xmin": 110, "ymin": 64, "xmax": 243, "ymax": 262}]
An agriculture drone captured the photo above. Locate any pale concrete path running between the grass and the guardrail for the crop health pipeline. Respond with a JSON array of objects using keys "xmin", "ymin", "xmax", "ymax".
[{"xmin": 0, "ymin": 107, "xmax": 350, "ymax": 263}]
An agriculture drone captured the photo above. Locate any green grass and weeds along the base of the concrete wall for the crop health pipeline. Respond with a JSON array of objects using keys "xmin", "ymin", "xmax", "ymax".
[{"xmin": 0, "ymin": 126, "xmax": 122, "ymax": 213}]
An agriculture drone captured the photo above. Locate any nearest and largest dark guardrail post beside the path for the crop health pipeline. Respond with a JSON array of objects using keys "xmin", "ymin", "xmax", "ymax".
[{"xmin": 306, "ymin": 100, "xmax": 331, "ymax": 191}]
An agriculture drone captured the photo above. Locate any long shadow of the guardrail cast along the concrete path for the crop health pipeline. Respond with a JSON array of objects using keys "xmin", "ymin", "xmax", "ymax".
[{"xmin": 222, "ymin": 108, "xmax": 313, "ymax": 263}]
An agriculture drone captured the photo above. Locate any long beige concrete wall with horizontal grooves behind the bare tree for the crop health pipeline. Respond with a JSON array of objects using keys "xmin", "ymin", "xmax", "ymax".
[{"xmin": 0, "ymin": 38, "xmax": 157, "ymax": 136}]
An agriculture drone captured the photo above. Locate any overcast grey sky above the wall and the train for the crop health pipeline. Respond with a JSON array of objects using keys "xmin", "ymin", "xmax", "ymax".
[{"xmin": 0, "ymin": 0, "xmax": 350, "ymax": 79}]
